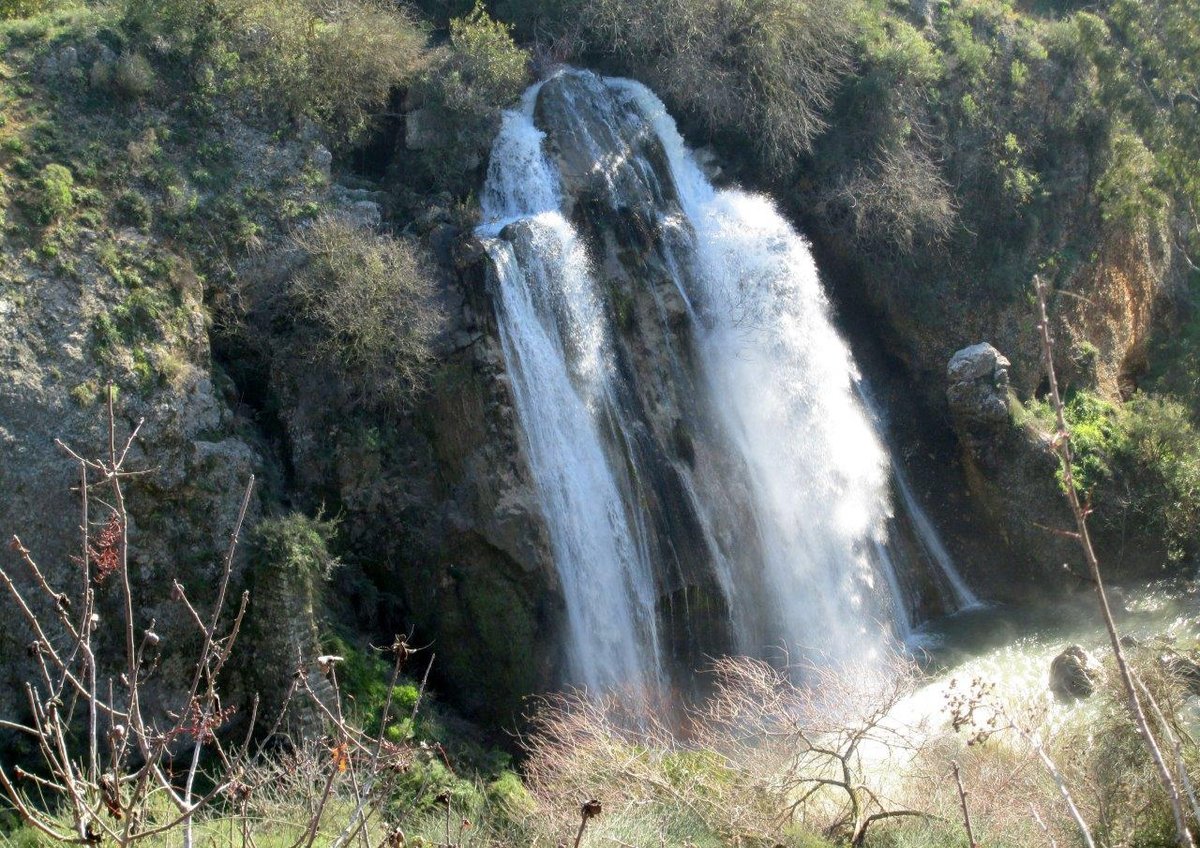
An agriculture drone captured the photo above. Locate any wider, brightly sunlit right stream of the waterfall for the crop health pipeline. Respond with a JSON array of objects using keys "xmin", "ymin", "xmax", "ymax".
[{"xmin": 610, "ymin": 80, "xmax": 905, "ymax": 660}]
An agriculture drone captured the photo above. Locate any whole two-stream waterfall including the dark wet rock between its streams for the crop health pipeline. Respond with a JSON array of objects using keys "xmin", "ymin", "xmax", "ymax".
[{"xmin": 478, "ymin": 71, "xmax": 965, "ymax": 691}]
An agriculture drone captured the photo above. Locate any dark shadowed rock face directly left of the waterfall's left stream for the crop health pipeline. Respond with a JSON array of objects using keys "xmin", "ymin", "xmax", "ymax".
[{"xmin": 275, "ymin": 231, "xmax": 563, "ymax": 727}]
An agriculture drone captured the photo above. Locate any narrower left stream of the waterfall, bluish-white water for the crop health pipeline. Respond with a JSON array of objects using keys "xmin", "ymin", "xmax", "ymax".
[{"xmin": 480, "ymin": 88, "xmax": 661, "ymax": 688}]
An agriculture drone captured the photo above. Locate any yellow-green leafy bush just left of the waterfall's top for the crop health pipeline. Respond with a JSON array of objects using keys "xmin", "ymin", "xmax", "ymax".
[{"xmin": 412, "ymin": 2, "xmax": 529, "ymax": 194}]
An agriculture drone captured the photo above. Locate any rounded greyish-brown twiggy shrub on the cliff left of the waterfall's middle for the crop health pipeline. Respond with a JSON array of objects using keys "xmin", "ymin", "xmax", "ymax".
[{"xmin": 289, "ymin": 217, "xmax": 442, "ymax": 403}]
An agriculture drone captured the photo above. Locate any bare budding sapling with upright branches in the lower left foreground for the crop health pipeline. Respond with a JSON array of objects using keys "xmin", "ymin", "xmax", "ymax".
[{"xmin": 0, "ymin": 386, "xmax": 254, "ymax": 846}]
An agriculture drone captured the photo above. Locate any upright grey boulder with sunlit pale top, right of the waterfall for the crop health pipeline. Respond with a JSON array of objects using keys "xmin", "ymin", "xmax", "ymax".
[{"xmin": 946, "ymin": 342, "xmax": 1012, "ymax": 467}]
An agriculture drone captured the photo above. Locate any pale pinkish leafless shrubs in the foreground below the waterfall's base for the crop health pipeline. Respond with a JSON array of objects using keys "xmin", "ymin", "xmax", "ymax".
[{"xmin": 524, "ymin": 657, "xmax": 930, "ymax": 846}]
